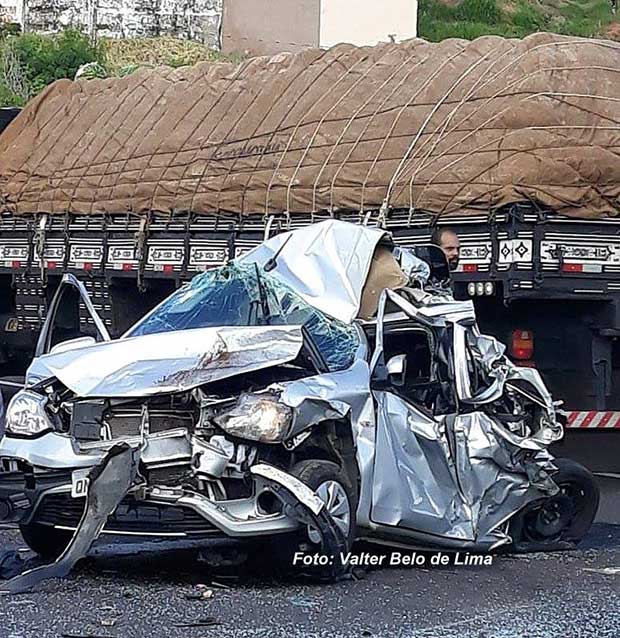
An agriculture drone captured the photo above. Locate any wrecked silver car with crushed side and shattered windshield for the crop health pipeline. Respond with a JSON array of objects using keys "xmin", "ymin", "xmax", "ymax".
[{"xmin": 0, "ymin": 221, "xmax": 598, "ymax": 589}]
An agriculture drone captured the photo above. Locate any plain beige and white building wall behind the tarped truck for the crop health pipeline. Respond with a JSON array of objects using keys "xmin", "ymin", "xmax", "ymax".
[{"xmin": 222, "ymin": 0, "xmax": 418, "ymax": 55}]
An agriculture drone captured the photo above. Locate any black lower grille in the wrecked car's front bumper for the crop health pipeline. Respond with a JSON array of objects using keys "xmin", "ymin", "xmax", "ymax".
[{"xmin": 33, "ymin": 494, "xmax": 220, "ymax": 537}]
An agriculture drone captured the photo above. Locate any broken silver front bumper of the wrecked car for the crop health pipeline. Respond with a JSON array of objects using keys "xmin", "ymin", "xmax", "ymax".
[{"xmin": 0, "ymin": 433, "xmax": 322, "ymax": 538}]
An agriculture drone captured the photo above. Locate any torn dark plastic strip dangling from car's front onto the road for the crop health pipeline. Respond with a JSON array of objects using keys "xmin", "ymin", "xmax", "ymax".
[{"xmin": 0, "ymin": 443, "xmax": 138, "ymax": 594}]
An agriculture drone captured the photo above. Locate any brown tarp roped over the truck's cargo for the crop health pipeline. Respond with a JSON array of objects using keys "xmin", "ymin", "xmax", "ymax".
[{"xmin": 0, "ymin": 34, "xmax": 620, "ymax": 217}]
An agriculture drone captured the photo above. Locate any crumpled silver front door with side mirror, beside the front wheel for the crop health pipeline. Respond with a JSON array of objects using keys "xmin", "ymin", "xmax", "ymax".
[{"xmin": 370, "ymin": 293, "xmax": 473, "ymax": 540}]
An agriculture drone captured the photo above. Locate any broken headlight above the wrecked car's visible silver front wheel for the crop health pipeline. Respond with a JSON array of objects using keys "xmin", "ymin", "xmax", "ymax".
[{"xmin": 214, "ymin": 393, "xmax": 293, "ymax": 443}]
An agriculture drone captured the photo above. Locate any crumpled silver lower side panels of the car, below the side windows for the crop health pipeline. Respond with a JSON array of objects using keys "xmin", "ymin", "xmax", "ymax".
[{"xmin": 371, "ymin": 392, "xmax": 556, "ymax": 549}]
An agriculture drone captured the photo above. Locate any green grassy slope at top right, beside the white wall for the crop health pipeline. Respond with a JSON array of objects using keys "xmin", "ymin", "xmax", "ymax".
[{"xmin": 418, "ymin": 0, "xmax": 614, "ymax": 42}]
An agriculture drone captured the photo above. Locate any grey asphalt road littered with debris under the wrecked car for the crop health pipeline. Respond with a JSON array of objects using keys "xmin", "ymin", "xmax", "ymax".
[{"xmin": 0, "ymin": 523, "xmax": 620, "ymax": 638}]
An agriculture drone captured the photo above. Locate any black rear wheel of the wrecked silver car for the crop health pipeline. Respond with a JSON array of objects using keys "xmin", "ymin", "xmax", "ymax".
[{"xmin": 511, "ymin": 459, "xmax": 600, "ymax": 550}]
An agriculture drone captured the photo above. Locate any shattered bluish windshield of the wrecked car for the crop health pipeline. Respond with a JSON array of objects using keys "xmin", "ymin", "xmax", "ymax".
[{"xmin": 125, "ymin": 263, "xmax": 359, "ymax": 370}]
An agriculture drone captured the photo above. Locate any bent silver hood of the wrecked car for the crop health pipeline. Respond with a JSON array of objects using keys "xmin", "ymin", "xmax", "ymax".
[{"xmin": 27, "ymin": 326, "xmax": 303, "ymax": 398}]
